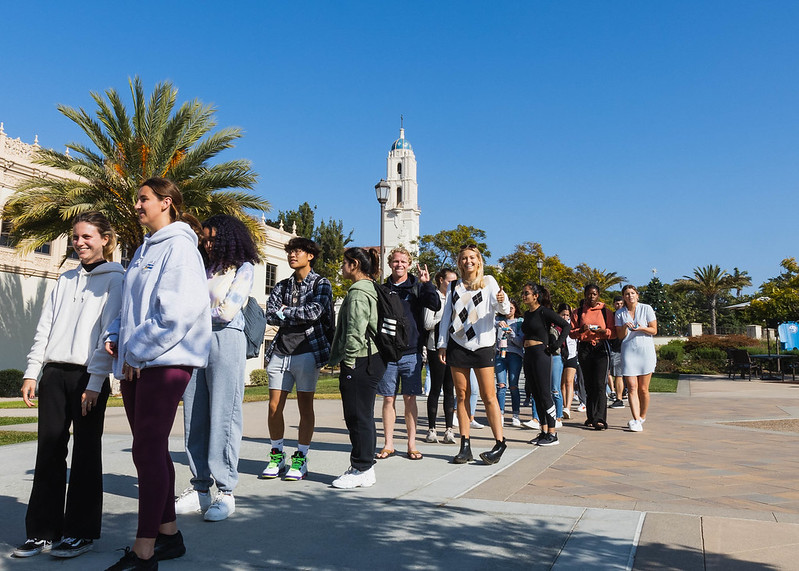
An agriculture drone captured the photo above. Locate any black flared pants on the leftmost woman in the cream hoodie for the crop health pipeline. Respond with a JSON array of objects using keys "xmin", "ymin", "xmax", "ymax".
[{"xmin": 25, "ymin": 363, "xmax": 110, "ymax": 541}]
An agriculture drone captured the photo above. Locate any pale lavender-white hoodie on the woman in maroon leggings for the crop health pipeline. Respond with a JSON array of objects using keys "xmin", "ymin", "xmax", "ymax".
[{"xmin": 106, "ymin": 222, "xmax": 211, "ymax": 378}]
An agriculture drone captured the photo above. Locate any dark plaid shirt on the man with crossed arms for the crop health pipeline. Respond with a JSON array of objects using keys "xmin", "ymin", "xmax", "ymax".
[{"xmin": 264, "ymin": 270, "xmax": 334, "ymax": 369}]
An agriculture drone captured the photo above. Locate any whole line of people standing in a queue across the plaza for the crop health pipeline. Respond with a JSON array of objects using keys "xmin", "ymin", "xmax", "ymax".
[{"xmin": 14, "ymin": 185, "xmax": 657, "ymax": 570}]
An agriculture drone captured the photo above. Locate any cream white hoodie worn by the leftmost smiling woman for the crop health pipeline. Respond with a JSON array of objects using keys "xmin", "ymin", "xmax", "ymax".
[{"xmin": 24, "ymin": 262, "xmax": 125, "ymax": 392}]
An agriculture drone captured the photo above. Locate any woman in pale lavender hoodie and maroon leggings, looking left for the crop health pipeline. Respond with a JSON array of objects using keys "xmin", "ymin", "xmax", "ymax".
[{"xmin": 106, "ymin": 177, "xmax": 211, "ymax": 570}]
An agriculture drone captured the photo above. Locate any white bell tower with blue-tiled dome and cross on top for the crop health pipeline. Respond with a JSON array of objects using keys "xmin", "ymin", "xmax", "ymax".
[{"xmin": 383, "ymin": 122, "xmax": 421, "ymax": 260}]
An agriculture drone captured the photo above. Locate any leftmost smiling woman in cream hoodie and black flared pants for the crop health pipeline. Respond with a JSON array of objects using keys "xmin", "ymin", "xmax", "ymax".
[{"xmin": 14, "ymin": 212, "xmax": 124, "ymax": 557}]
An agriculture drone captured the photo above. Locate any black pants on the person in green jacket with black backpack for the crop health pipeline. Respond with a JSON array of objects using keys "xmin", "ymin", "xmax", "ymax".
[{"xmin": 338, "ymin": 354, "xmax": 386, "ymax": 471}]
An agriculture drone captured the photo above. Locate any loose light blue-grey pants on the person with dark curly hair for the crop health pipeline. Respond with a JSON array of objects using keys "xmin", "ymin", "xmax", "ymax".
[{"xmin": 183, "ymin": 320, "xmax": 247, "ymax": 492}]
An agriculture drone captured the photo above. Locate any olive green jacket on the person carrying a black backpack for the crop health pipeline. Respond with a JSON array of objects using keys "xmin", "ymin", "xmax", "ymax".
[{"xmin": 330, "ymin": 280, "xmax": 377, "ymax": 367}]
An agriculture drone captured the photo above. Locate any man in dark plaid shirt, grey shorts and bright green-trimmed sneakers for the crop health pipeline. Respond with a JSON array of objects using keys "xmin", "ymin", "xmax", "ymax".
[{"xmin": 260, "ymin": 238, "xmax": 335, "ymax": 480}]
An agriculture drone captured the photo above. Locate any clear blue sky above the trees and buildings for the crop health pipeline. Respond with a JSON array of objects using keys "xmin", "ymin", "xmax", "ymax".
[{"xmin": 0, "ymin": 0, "xmax": 799, "ymax": 292}]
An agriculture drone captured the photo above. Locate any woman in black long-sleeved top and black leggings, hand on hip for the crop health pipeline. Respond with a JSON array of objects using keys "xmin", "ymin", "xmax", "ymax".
[{"xmin": 522, "ymin": 282, "xmax": 571, "ymax": 446}]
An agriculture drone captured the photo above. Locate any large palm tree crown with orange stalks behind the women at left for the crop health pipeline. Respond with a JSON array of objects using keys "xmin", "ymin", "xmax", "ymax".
[{"xmin": 3, "ymin": 77, "xmax": 270, "ymax": 253}]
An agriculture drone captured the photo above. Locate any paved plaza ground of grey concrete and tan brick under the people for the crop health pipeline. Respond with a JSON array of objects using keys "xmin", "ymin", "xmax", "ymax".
[{"xmin": 0, "ymin": 376, "xmax": 799, "ymax": 571}]
